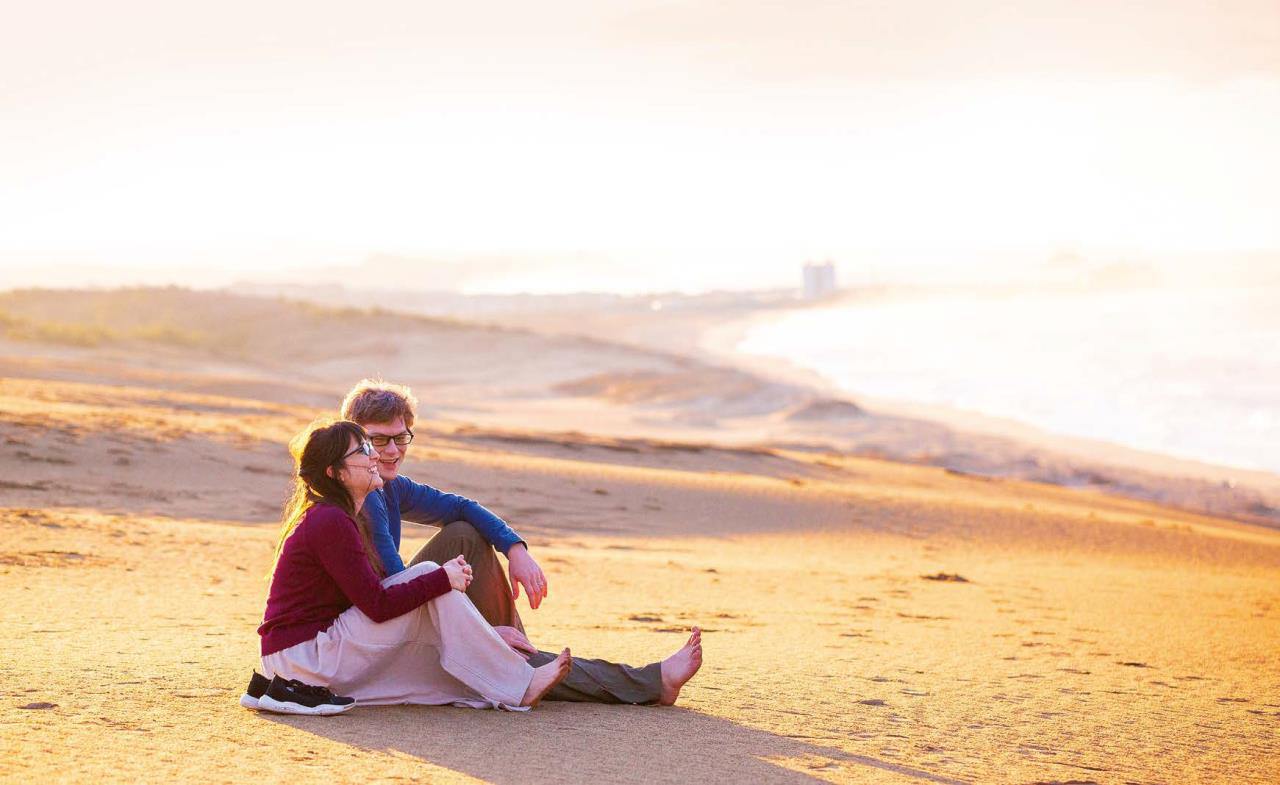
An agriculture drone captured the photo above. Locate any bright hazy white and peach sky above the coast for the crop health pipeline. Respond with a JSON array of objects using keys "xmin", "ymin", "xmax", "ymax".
[{"xmin": 0, "ymin": 0, "xmax": 1280, "ymax": 289}]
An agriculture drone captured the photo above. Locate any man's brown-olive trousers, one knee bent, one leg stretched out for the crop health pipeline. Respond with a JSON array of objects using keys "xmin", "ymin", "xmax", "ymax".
[{"xmin": 410, "ymin": 521, "xmax": 662, "ymax": 703}]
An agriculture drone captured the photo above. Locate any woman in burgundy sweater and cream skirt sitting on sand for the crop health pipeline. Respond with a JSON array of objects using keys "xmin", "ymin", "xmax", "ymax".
[{"xmin": 259, "ymin": 420, "xmax": 570, "ymax": 709}]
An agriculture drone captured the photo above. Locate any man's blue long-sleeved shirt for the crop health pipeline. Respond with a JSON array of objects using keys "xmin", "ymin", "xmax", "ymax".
[{"xmin": 364, "ymin": 475, "xmax": 525, "ymax": 575}]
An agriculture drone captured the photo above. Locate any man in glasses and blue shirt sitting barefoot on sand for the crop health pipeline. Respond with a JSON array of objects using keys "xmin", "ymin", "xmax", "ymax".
[{"xmin": 342, "ymin": 379, "xmax": 703, "ymax": 706}]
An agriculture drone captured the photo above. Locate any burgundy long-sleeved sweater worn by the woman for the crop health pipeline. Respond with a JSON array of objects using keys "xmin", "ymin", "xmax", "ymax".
[{"xmin": 257, "ymin": 505, "xmax": 452, "ymax": 657}]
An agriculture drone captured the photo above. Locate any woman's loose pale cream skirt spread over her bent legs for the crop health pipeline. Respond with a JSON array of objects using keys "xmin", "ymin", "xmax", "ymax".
[{"xmin": 262, "ymin": 562, "xmax": 534, "ymax": 711}]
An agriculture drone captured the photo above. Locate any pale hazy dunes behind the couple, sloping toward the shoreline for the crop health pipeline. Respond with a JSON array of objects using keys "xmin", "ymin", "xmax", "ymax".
[{"xmin": 0, "ymin": 288, "xmax": 1280, "ymax": 526}]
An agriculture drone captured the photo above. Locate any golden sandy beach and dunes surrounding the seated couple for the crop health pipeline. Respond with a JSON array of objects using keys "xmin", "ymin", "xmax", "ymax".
[{"xmin": 0, "ymin": 291, "xmax": 1280, "ymax": 785}]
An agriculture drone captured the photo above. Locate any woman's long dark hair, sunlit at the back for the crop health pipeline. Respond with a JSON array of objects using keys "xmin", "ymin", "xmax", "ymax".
[{"xmin": 275, "ymin": 420, "xmax": 387, "ymax": 576}]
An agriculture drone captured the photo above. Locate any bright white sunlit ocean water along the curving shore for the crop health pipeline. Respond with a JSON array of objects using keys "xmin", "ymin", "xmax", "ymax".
[{"xmin": 736, "ymin": 287, "xmax": 1280, "ymax": 473}]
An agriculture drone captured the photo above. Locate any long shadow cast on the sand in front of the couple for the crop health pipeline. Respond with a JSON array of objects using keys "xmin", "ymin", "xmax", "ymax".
[{"xmin": 270, "ymin": 703, "xmax": 964, "ymax": 785}]
